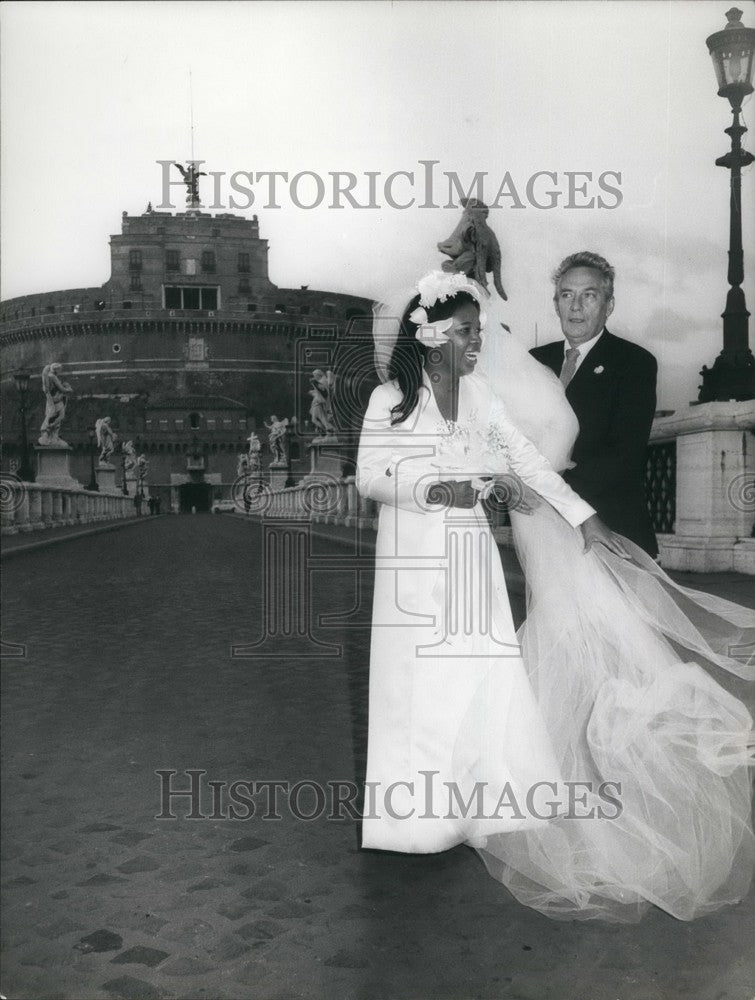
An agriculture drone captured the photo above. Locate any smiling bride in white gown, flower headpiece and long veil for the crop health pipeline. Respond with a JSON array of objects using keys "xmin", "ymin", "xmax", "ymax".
[{"xmin": 357, "ymin": 272, "xmax": 755, "ymax": 921}]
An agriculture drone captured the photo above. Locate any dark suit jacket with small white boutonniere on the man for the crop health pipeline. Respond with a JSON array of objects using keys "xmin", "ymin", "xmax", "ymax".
[{"xmin": 530, "ymin": 330, "xmax": 658, "ymax": 556}]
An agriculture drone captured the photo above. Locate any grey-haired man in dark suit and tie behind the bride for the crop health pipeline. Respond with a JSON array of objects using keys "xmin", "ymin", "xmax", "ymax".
[{"xmin": 530, "ymin": 251, "xmax": 658, "ymax": 556}]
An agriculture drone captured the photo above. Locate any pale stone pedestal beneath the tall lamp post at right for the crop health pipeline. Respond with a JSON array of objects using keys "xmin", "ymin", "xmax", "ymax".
[{"xmin": 651, "ymin": 402, "xmax": 755, "ymax": 574}]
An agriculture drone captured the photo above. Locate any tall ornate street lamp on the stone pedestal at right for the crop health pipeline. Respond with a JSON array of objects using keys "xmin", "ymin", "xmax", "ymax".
[{"xmin": 698, "ymin": 7, "xmax": 755, "ymax": 403}]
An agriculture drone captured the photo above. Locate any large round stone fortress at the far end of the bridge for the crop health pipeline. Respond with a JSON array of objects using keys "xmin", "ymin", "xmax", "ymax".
[{"xmin": 0, "ymin": 198, "xmax": 372, "ymax": 510}]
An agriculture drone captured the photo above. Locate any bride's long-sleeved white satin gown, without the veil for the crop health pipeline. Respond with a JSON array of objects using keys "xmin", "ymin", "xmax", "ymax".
[{"xmin": 357, "ymin": 375, "xmax": 594, "ymax": 853}]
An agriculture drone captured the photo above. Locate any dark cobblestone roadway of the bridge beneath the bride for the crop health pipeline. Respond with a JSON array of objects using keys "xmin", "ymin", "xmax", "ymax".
[{"xmin": 0, "ymin": 516, "xmax": 755, "ymax": 1000}]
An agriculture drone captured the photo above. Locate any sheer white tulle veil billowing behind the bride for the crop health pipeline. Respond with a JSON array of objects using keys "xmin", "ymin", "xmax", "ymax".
[{"xmin": 466, "ymin": 322, "xmax": 755, "ymax": 922}]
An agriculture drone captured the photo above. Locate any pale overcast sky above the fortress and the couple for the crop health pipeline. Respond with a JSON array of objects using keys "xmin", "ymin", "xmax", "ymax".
[{"xmin": 1, "ymin": 0, "xmax": 755, "ymax": 408}]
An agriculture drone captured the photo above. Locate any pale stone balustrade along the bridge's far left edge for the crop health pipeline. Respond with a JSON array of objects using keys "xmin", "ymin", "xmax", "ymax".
[{"xmin": 2, "ymin": 480, "xmax": 136, "ymax": 535}]
